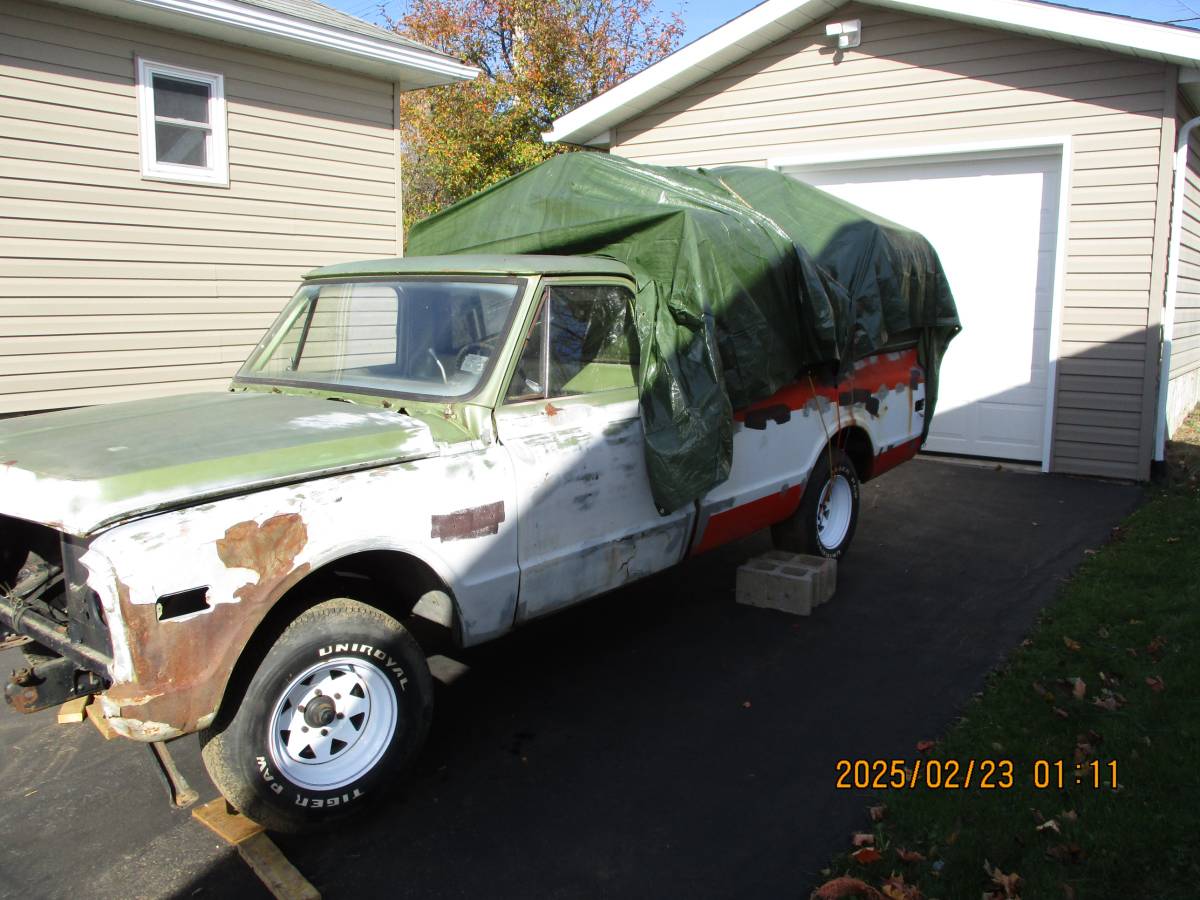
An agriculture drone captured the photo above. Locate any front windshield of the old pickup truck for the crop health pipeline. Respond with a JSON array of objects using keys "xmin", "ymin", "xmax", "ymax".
[{"xmin": 236, "ymin": 276, "xmax": 524, "ymax": 400}]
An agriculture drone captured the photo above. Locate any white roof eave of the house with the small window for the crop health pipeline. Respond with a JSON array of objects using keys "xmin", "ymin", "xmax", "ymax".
[{"xmin": 54, "ymin": 0, "xmax": 479, "ymax": 89}]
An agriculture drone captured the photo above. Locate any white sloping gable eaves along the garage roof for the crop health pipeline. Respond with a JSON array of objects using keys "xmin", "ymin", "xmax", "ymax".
[{"xmin": 542, "ymin": 0, "xmax": 1200, "ymax": 144}]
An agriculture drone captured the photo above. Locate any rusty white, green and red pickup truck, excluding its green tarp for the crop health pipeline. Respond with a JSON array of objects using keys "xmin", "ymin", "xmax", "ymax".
[{"xmin": 0, "ymin": 256, "xmax": 925, "ymax": 832}]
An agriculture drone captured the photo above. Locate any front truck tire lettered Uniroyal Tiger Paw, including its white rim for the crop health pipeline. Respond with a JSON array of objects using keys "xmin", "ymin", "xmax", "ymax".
[{"xmin": 200, "ymin": 599, "xmax": 433, "ymax": 833}]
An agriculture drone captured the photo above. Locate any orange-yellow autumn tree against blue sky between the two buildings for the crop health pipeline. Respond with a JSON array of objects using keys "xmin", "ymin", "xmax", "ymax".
[{"xmin": 391, "ymin": 0, "xmax": 683, "ymax": 230}]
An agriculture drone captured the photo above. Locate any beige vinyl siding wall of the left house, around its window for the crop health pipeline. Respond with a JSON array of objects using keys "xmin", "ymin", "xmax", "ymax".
[{"xmin": 0, "ymin": 0, "xmax": 400, "ymax": 414}]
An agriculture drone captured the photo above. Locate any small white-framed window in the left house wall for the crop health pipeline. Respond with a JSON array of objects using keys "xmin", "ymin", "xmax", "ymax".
[{"xmin": 138, "ymin": 59, "xmax": 229, "ymax": 185}]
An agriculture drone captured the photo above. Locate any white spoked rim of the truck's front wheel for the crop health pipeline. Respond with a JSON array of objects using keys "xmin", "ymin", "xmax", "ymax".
[{"xmin": 270, "ymin": 656, "xmax": 400, "ymax": 791}]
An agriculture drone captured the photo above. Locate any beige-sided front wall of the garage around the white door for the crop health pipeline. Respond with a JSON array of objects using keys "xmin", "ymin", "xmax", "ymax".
[{"xmin": 612, "ymin": 4, "xmax": 1176, "ymax": 479}]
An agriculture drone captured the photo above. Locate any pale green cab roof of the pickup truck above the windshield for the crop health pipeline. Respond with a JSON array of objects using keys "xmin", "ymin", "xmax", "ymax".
[{"xmin": 304, "ymin": 253, "xmax": 634, "ymax": 280}]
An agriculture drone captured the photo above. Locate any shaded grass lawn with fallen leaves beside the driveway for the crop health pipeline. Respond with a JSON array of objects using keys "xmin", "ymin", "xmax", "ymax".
[{"xmin": 814, "ymin": 409, "xmax": 1200, "ymax": 900}]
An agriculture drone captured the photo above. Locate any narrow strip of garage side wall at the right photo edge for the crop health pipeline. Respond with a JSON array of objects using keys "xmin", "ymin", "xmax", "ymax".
[{"xmin": 1166, "ymin": 100, "xmax": 1200, "ymax": 434}]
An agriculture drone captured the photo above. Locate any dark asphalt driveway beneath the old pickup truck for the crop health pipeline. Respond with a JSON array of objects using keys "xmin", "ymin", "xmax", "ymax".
[{"xmin": 0, "ymin": 458, "xmax": 1141, "ymax": 900}]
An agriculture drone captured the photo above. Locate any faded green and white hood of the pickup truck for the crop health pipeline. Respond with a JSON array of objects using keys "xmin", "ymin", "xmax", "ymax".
[{"xmin": 0, "ymin": 394, "xmax": 438, "ymax": 535}]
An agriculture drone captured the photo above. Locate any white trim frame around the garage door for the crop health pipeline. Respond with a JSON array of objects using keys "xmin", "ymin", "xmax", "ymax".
[{"xmin": 767, "ymin": 136, "xmax": 1072, "ymax": 472}]
